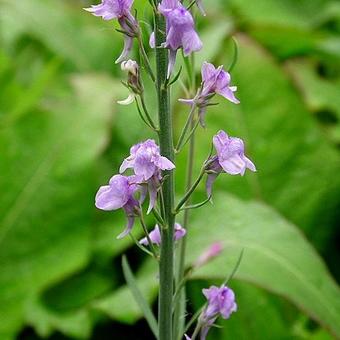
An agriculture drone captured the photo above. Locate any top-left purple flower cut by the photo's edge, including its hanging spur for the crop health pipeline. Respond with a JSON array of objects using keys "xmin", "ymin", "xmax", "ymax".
[{"xmin": 84, "ymin": 0, "xmax": 139, "ymax": 64}]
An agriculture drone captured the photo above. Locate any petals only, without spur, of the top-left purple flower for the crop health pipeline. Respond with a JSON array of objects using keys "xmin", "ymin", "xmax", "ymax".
[{"xmin": 84, "ymin": 0, "xmax": 133, "ymax": 20}]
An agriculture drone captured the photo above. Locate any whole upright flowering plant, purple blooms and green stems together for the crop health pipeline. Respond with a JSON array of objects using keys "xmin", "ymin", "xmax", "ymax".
[{"xmin": 86, "ymin": 0, "xmax": 256, "ymax": 340}]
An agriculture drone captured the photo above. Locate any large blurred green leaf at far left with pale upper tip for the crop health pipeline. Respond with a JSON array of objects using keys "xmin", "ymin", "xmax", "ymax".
[{"xmin": 0, "ymin": 75, "xmax": 115, "ymax": 338}]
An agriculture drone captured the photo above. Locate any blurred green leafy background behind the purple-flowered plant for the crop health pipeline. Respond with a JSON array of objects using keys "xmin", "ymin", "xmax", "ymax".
[{"xmin": 0, "ymin": 0, "xmax": 340, "ymax": 340}]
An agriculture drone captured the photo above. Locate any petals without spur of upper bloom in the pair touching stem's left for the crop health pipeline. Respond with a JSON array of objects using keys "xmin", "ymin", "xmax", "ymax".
[{"xmin": 119, "ymin": 139, "xmax": 175, "ymax": 181}]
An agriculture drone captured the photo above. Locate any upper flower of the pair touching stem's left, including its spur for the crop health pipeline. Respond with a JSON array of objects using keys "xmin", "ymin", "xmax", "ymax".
[{"xmin": 119, "ymin": 139, "xmax": 175, "ymax": 213}]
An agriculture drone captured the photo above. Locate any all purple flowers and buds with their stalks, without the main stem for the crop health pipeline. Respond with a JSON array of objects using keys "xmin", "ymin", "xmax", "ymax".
[{"xmin": 86, "ymin": 0, "xmax": 256, "ymax": 339}]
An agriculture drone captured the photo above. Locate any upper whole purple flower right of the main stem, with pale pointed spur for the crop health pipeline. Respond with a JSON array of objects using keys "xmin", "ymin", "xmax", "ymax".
[{"xmin": 180, "ymin": 62, "xmax": 240, "ymax": 126}]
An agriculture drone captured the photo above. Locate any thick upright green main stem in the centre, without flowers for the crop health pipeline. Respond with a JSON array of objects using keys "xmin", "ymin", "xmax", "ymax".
[{"xmin": 155, "ymin": 7, "xmax": 175, "ymax": 340}]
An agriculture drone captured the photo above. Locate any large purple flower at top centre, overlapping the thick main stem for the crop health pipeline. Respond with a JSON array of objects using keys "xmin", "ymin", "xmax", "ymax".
[{"xmin": 157, "ymin": 0, "xmax": 202, "ymax": 77}]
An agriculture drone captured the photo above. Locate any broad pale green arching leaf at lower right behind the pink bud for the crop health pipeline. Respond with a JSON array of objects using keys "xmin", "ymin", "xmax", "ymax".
[{"xmin": 188, "ymin": 193, "xmax": 340, "ymax": 336}]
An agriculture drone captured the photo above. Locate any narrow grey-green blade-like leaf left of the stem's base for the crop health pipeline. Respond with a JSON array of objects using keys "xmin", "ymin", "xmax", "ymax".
[{"xmin": 122, "ymin": 255, "xmax": 158, "ymax": 339}]
